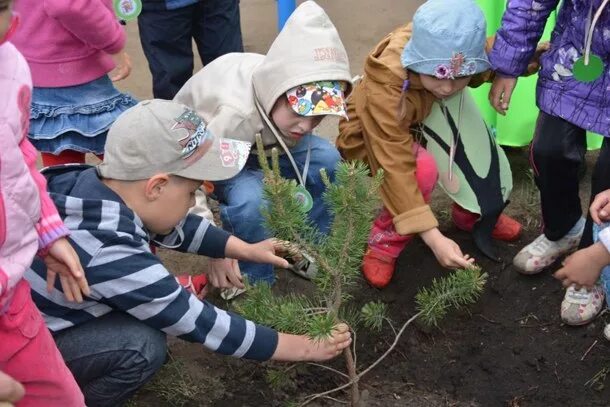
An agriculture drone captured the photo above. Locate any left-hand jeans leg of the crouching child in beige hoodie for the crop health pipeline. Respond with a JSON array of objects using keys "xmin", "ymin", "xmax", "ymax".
[{"xmin": 214, "ymin": 165, "xmax": 275, "ymax": 284}]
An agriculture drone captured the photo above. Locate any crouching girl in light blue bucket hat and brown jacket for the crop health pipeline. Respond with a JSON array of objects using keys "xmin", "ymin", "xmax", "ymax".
[{"xmin": 337, "ymin": 0, "xmax": 536, "ymax": 288}]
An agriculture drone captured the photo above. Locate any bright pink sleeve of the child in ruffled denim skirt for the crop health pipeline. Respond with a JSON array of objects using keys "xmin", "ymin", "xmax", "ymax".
[{"xmin": 43, "ymin": 0, "xmax": 125, "ymax": 54}]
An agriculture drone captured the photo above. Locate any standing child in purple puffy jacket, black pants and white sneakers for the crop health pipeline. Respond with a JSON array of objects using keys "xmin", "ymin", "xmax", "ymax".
[{"xmin": 489, "ymin": 0, "xmax": 610, "ymax": 325}]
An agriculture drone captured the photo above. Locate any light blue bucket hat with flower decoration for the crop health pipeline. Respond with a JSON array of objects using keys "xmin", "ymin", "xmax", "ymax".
[{"xmin": 400, "ymin": 0, "xmax": 491, "ymax": 79}]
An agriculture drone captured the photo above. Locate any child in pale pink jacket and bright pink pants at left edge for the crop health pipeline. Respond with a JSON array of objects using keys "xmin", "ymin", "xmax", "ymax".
[{"xmin": 0, "ymin": 0, "xmax": 88, "ymax": 407}]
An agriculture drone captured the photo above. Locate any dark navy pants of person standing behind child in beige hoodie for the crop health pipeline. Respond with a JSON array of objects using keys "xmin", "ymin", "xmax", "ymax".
[{"xmin": 138, "ymin": 0, "xmax": 243, "ymax": 99}]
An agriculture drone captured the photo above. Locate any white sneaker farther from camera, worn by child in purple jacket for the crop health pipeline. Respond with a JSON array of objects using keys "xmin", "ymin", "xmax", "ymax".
[{"xmin": 513, "ymin": 218, "xmax": 585, "ymax": 274}]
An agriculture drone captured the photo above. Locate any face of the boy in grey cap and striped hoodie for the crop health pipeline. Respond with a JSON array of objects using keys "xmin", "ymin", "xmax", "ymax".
[{"xmin": 144, "ymin": 175, "xmax": 202, "ymax": 235}]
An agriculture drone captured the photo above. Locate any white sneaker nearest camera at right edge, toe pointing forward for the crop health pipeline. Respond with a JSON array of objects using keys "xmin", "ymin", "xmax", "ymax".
[{"xmin": 561, "ymin": 285, "xmax": 604, "ymax": 325}]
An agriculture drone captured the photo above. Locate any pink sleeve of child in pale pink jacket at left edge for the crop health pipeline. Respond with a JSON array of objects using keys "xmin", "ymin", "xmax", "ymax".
[{"xmin": 19, "ymin": 137, "xmax": 70, "ymax": 254}]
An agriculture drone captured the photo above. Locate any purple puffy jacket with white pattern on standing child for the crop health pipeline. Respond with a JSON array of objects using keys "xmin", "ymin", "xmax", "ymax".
[{"xmin": 489, "ymin": 0, "xmax": 610, "ymax": 137}]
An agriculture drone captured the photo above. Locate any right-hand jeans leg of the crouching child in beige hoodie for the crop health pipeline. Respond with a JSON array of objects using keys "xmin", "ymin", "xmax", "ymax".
[{"xmin": 280, "ymin": 135, "xmax": 341, "ymax": 233}]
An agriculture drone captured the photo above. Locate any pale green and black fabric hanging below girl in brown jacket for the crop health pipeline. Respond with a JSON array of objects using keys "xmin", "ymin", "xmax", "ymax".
[{"xmin": 422, "ymin": 90, "xmax": 513, "ymax": 213}]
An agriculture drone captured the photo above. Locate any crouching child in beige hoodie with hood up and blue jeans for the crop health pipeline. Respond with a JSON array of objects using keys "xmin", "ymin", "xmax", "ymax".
[{"xmin": 174, "ymin": 1, "xmax": 351, "ymax": 292}]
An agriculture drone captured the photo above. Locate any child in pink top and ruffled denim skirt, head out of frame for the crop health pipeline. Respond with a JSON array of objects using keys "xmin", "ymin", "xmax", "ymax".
[{"xmin": 11, "ymin": 0, "xmax": 136, "ymax": 166}]
